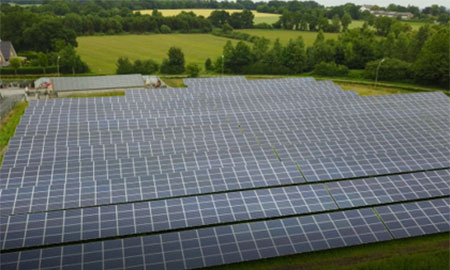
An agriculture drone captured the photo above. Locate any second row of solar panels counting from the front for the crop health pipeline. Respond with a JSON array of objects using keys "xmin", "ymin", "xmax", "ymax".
[{"xmin": 1, "ymin": 170, "xmax": 450, "ymax": 249}]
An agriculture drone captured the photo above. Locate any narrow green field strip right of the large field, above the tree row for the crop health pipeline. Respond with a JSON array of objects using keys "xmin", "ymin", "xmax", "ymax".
[{"xmin": 237, "ymin": 29, "xmax": 339, "ymax": 46}]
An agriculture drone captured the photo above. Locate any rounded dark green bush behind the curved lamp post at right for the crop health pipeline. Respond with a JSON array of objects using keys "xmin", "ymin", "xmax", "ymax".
[{"xmin": 364, "ymin": 58, "xmax": 412, "ymax": 81}]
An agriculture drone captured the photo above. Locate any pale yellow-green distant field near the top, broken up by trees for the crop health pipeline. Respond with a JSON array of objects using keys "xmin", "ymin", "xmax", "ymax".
[{"xmin": 139, "ymin": 9, "xmax": 280, "ymax": 24}]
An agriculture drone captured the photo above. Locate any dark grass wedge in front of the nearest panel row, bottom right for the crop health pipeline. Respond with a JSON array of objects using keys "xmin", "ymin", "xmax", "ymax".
[{"xmin": 211, "ymin": 233, "xmax": 450, "ymax": 270}]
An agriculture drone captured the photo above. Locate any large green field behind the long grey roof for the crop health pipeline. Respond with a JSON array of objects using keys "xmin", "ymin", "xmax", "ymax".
[{"xmin": 77, "ymin": 34, "xmax": 243, "ymax": 74}]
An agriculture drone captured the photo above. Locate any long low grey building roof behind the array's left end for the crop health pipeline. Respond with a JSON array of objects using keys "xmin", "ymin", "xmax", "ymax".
[{"xmin": 35, "ymin": 74, "xmax": 145, "ymax": 92}]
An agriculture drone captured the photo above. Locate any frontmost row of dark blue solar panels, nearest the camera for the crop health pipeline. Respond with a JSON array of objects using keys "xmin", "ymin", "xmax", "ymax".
[{"xmin": 1, "ymin": 198, "xmax": 450, "ymax": 269}]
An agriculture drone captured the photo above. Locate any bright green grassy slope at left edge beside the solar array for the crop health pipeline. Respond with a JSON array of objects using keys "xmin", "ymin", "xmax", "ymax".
[{"xmin": 0, "ymin": 102, "xmax": 28, "ymax": 167}]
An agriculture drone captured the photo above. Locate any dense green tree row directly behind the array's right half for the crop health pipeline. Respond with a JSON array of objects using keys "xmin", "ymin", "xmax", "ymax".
[{"xmin": 214, "ymin": 25, "xmax": 450, "ymax": 86}]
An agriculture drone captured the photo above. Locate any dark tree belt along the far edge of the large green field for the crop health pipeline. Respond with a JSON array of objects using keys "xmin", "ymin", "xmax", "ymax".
[{"xmin": 0, "ymin": 2, "xmax": 254, "ymax": 52}]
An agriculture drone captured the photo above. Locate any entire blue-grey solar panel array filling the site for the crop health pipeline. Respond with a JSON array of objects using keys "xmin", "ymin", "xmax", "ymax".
[{"xmin": 0, "ymin": 77, "xmax": 450, "ymax": 269}]
